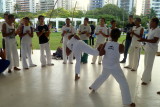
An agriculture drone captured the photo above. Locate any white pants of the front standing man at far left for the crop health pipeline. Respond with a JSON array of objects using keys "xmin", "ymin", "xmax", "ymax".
[{"xmin": 5, "ymin": 37, "xmax": 19, "ymax": 69}]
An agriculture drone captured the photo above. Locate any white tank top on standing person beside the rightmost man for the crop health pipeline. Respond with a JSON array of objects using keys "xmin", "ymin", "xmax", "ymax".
[{"xmin": 131, "ymin": 26, "xmax": 143, "ymax": 47}]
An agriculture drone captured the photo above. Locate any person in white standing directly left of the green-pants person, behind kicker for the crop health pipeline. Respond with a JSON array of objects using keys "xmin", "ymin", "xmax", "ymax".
[{"xmin": 62, "ymin": 18, "xmax": 76, "ymax": 64}]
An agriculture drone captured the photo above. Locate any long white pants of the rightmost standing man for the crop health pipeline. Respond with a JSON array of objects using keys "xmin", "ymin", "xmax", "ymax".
[{"xmin": 142, "ymin": 46, "xmax": 157, "ymax": 83}]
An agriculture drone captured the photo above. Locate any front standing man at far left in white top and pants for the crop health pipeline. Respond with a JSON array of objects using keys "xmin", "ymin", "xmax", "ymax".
[{"xmin": 2, "ymin": 15, "xmax": 20, "ymax": 73}]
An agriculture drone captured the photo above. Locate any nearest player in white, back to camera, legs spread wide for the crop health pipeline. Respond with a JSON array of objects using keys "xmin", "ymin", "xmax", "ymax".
[{"xmin": 89, "ymin": 29, "xmax": 135, "ymax": 107}]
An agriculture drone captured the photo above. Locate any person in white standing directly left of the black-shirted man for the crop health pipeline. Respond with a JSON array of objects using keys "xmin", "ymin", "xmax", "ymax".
[{"xmin": 20, "ymin": 17, "xmax": 37, "ymax": 69}]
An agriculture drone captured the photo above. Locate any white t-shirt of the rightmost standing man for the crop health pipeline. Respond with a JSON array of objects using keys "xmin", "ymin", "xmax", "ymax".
[{"xmin": 146, "ymin": 27, "xmax": 160, "ymax": 51}]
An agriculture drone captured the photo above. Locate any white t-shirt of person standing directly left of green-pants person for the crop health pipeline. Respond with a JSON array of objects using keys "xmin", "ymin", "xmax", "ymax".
[{"xmin": 62, "ymin": 25, "xmax": 76, "ymax": 42}]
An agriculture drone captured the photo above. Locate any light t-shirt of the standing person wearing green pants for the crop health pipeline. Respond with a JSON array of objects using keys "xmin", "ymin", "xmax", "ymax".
[{"xmin": 79, "ymin": 24, "xmax": 91, "ymax": 40}]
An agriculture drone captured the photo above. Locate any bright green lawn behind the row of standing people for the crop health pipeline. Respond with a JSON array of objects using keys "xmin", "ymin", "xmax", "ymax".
[{"xmin": 0, "ymin": 32, "xmax": 125, "ymax": 50}]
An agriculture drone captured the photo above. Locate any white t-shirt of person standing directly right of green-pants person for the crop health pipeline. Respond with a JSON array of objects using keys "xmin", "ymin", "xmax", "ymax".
[{"xmin": 95, "ymin": 25, "xmax": 108, "ymax": 43}]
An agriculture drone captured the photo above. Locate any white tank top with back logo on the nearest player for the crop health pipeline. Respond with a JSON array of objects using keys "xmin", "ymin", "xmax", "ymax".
[{"xmin": 103, "ymin": 41, "xmax": 120, "ymax": 68}]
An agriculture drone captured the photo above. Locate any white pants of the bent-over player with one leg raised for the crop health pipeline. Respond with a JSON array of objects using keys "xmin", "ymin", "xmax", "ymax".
[{"xmin": 73, "ymin": 42, "xmax": 99, "ymax": 74}]
